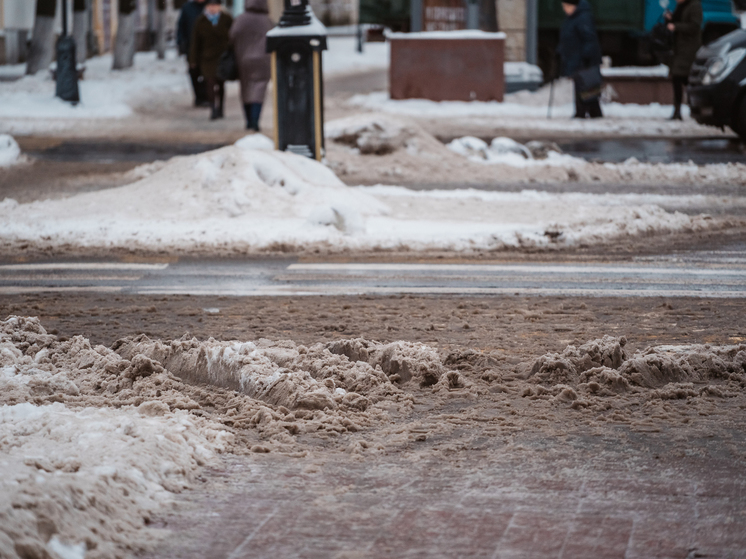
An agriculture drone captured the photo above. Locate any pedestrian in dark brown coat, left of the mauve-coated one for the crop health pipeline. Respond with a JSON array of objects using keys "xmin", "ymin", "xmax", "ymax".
[{"xmin": 189, "ymin": 0, "xmax": 233, "ymax": 120}]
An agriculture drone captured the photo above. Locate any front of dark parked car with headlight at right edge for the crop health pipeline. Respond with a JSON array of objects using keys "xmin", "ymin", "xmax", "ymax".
[{"xmin": 687, "ymin": 29, "xmax": 746, "ymax": 141}]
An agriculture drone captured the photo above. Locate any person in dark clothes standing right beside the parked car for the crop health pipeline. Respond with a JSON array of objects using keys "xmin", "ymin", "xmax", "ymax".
[{"xmin": 666, "ymin": 0, "xmax": 702, "ymax": 120}]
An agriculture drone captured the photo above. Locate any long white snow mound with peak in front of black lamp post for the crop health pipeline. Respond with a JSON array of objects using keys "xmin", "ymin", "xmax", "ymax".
[{"xmin": 0, "ymin": 133, "xmax": 746, "ymax": 254}]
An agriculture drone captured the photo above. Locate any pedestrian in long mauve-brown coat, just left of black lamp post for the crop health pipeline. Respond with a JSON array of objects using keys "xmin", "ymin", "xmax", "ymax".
[{"xmin": 231, "ymin": 0, "xmax": 273, "ymax": 132}]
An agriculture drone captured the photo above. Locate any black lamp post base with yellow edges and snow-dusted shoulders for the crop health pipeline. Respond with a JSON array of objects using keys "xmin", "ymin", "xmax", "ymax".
[{"xmin": 267, "ymin": 0, "xmax": 326, "ymax": 161}]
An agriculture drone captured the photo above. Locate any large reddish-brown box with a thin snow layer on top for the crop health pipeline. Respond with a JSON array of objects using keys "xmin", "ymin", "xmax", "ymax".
[{"xmin": 389, "ymin": 31, "xmax": 505, "ymax": 101}]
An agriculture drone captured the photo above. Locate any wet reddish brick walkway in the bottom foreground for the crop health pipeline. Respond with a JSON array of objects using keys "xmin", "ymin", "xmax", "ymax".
[{"xmin": 140, "ymin": 433, "xmax": 746, "ymax": 559}]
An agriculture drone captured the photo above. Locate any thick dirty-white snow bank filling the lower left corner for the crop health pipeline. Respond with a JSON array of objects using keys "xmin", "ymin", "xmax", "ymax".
[{"xmin": 0, "ymin": 317, "xmax": 233, "ymax": 558}]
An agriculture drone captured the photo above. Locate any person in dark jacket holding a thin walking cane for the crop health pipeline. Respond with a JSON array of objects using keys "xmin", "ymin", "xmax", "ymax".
[{"xmin": 557, "ymin": 0, "xmax": 603, "ymax": 118}]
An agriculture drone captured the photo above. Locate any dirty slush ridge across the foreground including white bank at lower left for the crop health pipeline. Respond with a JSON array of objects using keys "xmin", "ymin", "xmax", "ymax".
[{"xmin": 0, "ymin": 316, "xmax": 746, "ymax": 559}]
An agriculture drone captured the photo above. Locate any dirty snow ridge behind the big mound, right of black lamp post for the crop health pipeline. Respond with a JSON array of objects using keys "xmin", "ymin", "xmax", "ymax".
[{"xmin": 327, "ymin": 113, "xmax": 746, "ymax": 188}]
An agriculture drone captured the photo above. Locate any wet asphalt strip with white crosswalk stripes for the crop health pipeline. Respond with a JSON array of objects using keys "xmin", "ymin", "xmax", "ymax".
[{"xmin": 0, "ymin": 252, "xmax": 746, "ymax": 297}]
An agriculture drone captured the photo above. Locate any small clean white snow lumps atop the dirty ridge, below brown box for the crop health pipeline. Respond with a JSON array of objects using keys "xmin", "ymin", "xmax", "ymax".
[{"xmin": 446, "ymin": 136, "xmax": 586, "ymax": 167}]
